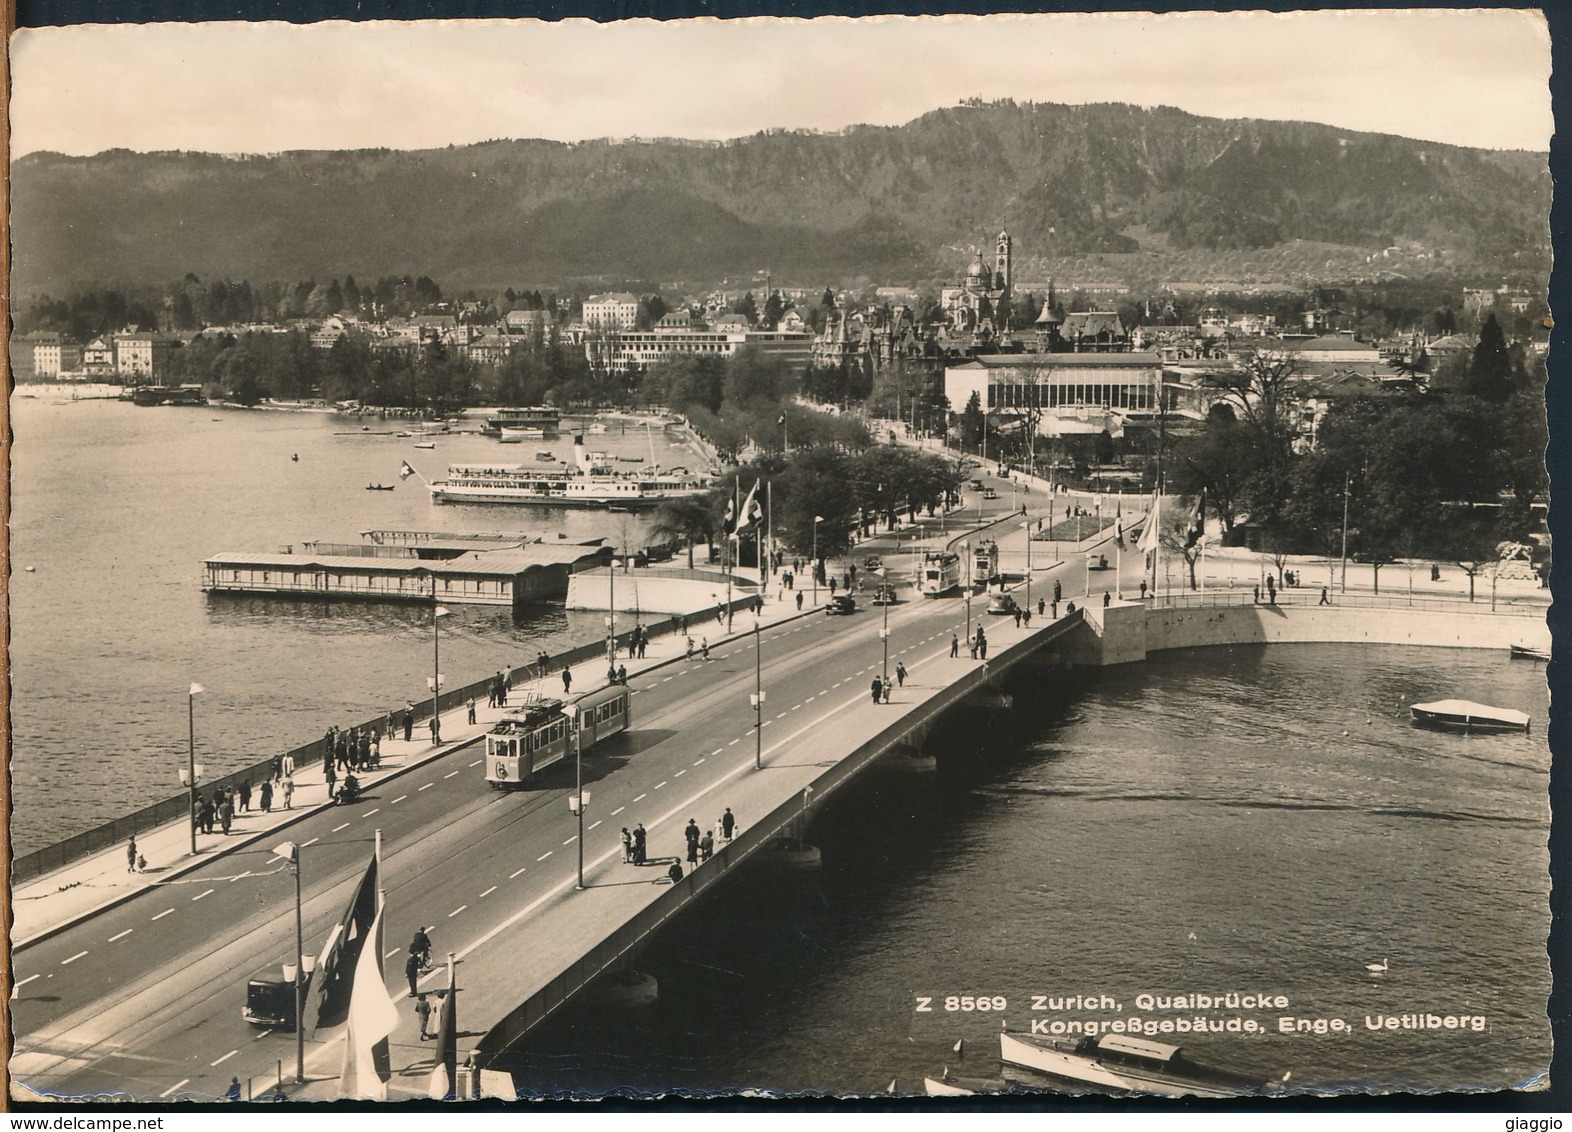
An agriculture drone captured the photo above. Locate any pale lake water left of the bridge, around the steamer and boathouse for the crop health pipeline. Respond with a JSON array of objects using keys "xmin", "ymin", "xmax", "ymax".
[{"xmin": 11, "ymin": 398, "xmax": 698, "ymax": 854}]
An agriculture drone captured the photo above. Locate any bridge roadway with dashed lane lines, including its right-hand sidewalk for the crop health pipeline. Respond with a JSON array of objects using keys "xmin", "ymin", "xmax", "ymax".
[{"xmin": 11, "ymin": 496, "xmax": 1125, "ymax": 1099}]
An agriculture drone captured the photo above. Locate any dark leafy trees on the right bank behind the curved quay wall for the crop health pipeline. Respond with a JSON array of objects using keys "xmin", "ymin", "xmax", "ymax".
[{"xmin": 1170, "ymin": 318, "xmax": 1548, "ymax": 578}]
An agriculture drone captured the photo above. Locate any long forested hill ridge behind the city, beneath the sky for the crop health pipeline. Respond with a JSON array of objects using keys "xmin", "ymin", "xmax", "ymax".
[{"xmin": 11, "ymin": 102, "xmax": 1550, "ymax": 297}]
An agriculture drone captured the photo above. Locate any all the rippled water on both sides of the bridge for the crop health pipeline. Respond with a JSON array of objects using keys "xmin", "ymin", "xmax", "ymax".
[{"xmin": 11, "ymin": 399, "xmax": 1550, "ymax": 1093}]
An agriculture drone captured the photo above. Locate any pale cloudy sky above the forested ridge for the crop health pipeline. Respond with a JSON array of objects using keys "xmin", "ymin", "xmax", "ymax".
[{"xmin": 11, "ymin": 9, "xmax": 1553, "ymax": 156}]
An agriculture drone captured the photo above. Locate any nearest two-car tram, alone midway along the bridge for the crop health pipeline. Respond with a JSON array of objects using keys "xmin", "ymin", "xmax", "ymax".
[{"xmin": 486, "ymin": 684, "xmax": 632, "ymax": 789}]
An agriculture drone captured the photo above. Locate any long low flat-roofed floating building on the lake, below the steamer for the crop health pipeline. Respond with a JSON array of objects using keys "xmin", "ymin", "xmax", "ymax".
[{"xmin": 194, "ymin": 531, "xmax": 612, "ymax": 605}]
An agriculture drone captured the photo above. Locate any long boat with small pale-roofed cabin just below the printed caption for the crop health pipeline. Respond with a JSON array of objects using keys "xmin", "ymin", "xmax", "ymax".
[{"xmin": 998, "ymin": 1031, "xmax": 1265, "ymax": 1096}]
